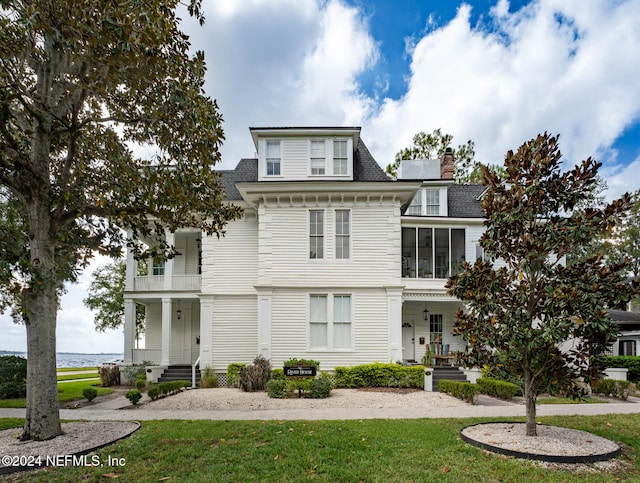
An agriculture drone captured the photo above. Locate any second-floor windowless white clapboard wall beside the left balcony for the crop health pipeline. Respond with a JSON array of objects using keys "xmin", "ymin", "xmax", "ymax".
[{"xmin": 202, "ymin": 214, "xmax": 258, "ymax": 294}]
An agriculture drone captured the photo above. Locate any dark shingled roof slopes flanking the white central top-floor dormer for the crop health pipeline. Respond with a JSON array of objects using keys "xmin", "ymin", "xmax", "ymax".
[{"xmin": 218, "ymin": 139, "xmax": 393, "ymax": 201}]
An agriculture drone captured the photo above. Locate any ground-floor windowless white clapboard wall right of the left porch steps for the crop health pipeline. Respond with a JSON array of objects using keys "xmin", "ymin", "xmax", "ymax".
[{"xmin": 211, "ymin": 295, "xmax": 258, "ymax": 372}]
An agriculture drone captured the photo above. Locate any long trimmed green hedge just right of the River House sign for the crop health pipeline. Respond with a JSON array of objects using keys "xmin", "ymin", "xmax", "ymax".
[{"xmin": 335, "ymin": 362, "xmax": 424, "ymax": 388}]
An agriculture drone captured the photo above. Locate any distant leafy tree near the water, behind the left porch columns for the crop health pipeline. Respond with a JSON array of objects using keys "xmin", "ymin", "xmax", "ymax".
[{"xmin": 82, "ymin": 260, "xmax": 145, "ymax": 339}]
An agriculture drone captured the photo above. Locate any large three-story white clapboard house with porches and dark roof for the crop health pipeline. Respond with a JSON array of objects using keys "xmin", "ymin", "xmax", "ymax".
[{"xmin": 124, "ymin": 127, "xmax": 484, "ymax": 380}]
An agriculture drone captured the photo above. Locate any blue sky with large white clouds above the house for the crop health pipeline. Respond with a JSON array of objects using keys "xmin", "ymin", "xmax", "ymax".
[{"xmin": 0, "ymin": 0, "xmax": 640, "ymax": 352}]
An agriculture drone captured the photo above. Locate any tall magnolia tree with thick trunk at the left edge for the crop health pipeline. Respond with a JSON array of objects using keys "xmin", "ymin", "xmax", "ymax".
[{"xmin": 0, "ymin": 0, "xmax": 241, "ymax": 440}]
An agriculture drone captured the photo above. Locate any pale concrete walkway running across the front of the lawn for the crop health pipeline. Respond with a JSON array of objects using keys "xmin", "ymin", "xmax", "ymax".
[{"xmin": 5, "ymin": 396, "xmax": 640, "ymax": 421}]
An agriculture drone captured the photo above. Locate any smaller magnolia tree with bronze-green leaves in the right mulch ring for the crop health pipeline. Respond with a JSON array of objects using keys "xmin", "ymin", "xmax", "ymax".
[{"xmin": 447, "ymin": 134, "xmax": 638, "ymax": 436}]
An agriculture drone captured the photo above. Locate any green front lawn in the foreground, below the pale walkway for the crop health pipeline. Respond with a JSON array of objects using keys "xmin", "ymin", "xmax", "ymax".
[{"xmin": 0, "ymin": 415, "xmax": 640, "ymax": 483}]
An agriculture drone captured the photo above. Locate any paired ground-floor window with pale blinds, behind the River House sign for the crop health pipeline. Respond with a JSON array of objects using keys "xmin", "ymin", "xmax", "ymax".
[{"xmin": 309, "ymin": 294, "xmax": 351, "ymax": 350}]
